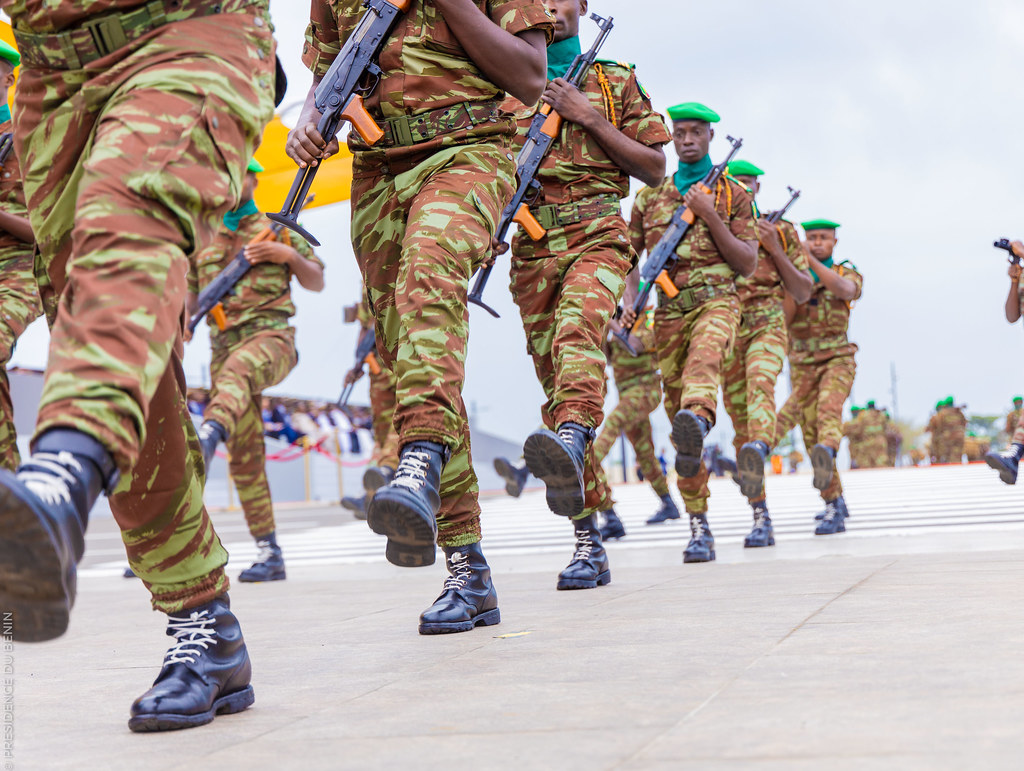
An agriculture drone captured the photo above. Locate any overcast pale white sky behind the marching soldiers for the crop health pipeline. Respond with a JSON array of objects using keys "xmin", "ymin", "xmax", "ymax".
[{"xmin": 8, "ymin": 0, "xmax": 1024, "ymax": 445}]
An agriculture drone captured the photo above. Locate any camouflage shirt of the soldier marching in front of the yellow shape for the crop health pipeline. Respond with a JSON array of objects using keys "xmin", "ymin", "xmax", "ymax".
[{"xmin": 196, "ymin": 214, "xmax": 324, "ymax": 337}]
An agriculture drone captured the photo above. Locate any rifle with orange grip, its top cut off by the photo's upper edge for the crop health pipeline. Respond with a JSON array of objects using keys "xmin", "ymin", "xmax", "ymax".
[{"xmin": 266, "ymin": 0, "xmax": 413, "ymax": 247}]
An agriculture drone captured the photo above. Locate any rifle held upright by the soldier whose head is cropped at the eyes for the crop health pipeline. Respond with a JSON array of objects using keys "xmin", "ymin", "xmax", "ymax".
[{"xmin": 468, "ymin": 13, "xmax": 614, "ymax": 318}]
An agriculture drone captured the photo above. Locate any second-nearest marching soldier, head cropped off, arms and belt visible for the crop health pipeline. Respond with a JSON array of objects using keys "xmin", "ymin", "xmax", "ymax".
[{"xmin": 288, "ymin": 0, "xmax": 552, "ymax": 634}]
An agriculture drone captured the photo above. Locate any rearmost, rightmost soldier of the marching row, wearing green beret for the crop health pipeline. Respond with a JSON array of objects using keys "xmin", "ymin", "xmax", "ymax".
[{"xmin": 776, "ymin": 219, "xmax": 864, "ymax": 536}]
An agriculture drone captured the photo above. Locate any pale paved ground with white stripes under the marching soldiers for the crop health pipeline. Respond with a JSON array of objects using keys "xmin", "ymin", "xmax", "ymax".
[{"xmin": 13, "ymin": 468, "xmax": 1024, "ymax": 769}]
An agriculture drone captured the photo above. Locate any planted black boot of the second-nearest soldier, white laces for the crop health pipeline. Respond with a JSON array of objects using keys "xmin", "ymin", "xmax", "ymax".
[{"xmin": 420, "ymin": 543, "xmax": 502, "ymax": 635}]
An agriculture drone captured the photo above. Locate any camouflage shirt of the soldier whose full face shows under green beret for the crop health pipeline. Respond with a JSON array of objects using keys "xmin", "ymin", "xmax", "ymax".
[{"xmin": 630, "ymin": 176, "xmax": 758, "ymax": 294}]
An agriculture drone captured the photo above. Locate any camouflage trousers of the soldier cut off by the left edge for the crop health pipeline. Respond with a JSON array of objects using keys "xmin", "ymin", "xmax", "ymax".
[{"xmin": 0, "ymin": 246, "xmax": 43, "ymax": 471}]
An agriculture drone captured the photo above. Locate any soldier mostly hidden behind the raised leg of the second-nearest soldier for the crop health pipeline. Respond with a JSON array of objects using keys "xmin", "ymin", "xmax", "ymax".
[{"xmin": 341, "ymin": 290, "xmax": 398, "ymax": 519}]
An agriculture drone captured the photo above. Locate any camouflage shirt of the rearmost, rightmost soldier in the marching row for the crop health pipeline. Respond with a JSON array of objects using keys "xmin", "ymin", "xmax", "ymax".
[{"xmin": 790, "ymin": 261, "xmax": 864, "ymax": 365}]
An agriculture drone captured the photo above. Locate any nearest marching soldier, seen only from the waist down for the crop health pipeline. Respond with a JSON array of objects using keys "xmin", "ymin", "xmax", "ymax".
[{"xmin": 0, "ymin": 0, "xmax": 274, "ymax": 731}]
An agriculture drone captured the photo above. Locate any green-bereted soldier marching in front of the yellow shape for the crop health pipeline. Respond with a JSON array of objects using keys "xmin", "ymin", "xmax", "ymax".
[{"xmin": 196, "ymin": 160, "xmax": 324, "ymax": 582}]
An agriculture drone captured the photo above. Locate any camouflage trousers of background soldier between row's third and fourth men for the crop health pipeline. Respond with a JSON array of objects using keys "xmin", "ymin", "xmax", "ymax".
[{"xmin": 594, "ymin": 380, "xmax": 669, "ymax": 498}]
